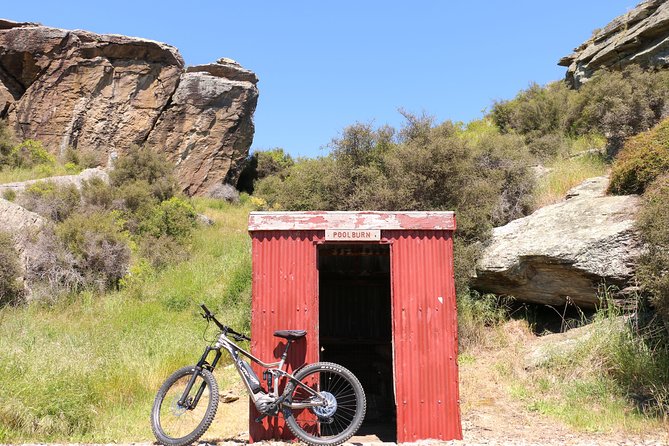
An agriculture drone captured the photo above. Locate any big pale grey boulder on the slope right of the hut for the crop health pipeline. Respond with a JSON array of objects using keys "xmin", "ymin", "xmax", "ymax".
[{"xmin": 472, "ymin": 177, "xmax": 640, "ymax": 307}]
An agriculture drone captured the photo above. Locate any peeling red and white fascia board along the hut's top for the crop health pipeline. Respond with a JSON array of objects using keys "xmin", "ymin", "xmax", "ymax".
[{"xmin": 249, "ymin": 211, "xmax": 455, "ymax": 231}]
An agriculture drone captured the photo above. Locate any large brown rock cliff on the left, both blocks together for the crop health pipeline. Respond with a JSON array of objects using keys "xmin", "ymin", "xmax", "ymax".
[{"xmin": 0, "ymin": 20, "xmax": 258, "ymax": 194}]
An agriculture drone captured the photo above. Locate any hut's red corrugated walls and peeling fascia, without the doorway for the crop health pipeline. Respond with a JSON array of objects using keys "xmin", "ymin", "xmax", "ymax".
[{"xmin": 249, "ymin": 212, "xmax": 462, "ymax": 442}]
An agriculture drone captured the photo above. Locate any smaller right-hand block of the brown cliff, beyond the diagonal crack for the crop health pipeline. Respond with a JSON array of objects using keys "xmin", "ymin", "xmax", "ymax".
[{"xmin": 147, "ymin": 59, "xmax": 258, "ymax": 195}]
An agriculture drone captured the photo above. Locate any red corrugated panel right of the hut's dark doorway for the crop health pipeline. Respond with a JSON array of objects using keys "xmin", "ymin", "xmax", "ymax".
[{"xmin": 387, "ymin": 231, "xmax": 462, "ymax": 443}]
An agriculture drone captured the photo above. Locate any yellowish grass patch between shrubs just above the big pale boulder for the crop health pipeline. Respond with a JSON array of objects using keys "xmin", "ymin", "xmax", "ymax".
[{"xmin": 534, "ymin": 154, "xmax": 609, "ymax": 209}]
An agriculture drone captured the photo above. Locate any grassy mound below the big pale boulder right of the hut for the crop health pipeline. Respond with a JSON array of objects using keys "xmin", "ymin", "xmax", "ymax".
[{"xmin": 506, "ymin": 311, "xmax": 662, "ymax": 433}]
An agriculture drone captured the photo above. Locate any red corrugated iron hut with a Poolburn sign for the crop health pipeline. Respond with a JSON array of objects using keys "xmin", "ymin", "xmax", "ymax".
[{"xmin": 249, "ymin": 212, "xmax": 462, "ymax": 443}]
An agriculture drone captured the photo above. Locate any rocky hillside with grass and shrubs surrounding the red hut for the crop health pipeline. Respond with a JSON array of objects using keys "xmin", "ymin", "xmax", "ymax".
[{"xmin": 0, "ymin": 0, "xmax": 669, "ymax": 446}]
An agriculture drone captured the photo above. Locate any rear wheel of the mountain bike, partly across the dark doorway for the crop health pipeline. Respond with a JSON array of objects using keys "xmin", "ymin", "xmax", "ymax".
[{"xmin": 284, "ymin": 362, "xmax": 366, "ymax": 446}]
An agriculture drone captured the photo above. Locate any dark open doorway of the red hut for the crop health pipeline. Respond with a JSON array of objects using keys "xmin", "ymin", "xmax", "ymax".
[{"xmin": 318, "ymin": 244, "xmax": 397, "ymax": 442}]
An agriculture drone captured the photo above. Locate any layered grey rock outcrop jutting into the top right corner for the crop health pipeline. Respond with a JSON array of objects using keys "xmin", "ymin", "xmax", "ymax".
[{"xmin": 558, "ymin": 0, "xmax": 669, "ymax": 88}]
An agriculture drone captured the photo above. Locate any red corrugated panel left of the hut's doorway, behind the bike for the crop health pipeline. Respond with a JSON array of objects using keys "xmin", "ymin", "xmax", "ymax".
[{"xmin": 249, "ymin": 231, "xmax": 319, "ymax": 442}]
